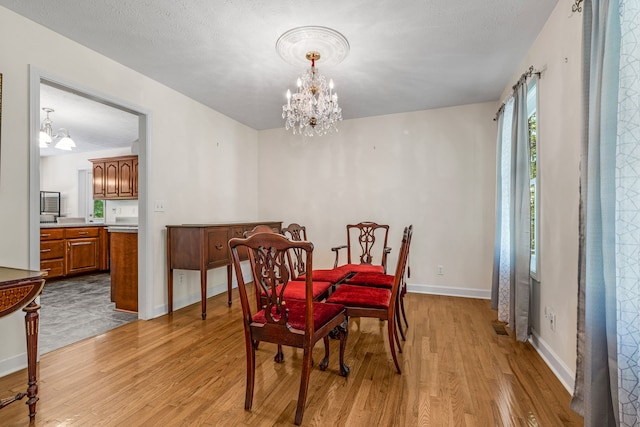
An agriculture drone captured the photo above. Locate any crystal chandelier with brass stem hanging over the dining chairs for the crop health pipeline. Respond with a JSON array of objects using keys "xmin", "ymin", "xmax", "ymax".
[{"xmin": 282, "ymin": 51, "xmax": 342, "ymax": 136}]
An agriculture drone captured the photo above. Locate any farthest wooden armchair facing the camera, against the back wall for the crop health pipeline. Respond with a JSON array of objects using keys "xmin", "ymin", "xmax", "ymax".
[{"xmin": 331, "ymin": 222, "xmax": 391, "ymax": 273}]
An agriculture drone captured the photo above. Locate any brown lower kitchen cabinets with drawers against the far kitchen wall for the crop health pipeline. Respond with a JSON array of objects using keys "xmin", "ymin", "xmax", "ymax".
[{"xmin": 40, "ymin": 226, "xmax": 108, "ymax": 279}]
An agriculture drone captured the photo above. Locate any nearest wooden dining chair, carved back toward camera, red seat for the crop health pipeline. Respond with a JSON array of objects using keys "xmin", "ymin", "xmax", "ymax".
[{"xmin": 229, "ymin": 233, "xmax": 349, "ymax": 425}]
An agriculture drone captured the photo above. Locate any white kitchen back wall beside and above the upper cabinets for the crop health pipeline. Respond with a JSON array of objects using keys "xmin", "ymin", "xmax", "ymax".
[{"xmin": 40, "ymin": 148, "xmax": 131, "ymax": 217}]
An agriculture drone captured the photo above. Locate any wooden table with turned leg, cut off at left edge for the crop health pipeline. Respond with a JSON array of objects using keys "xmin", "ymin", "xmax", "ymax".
[{"xmin": 0, "ymin": 267, "xmax": 44, "ymax": 419}]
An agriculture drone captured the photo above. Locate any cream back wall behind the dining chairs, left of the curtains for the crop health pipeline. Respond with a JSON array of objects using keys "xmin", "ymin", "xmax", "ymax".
[{"xmin": 258, "ymin": 102, "xmax": 498, "ymax": 297}]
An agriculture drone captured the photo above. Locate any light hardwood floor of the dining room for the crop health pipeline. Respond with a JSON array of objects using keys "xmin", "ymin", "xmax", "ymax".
[{"xmin": 0, "ymin": 294, "xmax": 583, "ymax": 427}]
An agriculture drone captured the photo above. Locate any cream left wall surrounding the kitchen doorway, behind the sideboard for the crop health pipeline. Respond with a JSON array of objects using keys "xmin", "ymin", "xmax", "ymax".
[{"xmin": 0, "ymin": 7, "xmax": 258, "ymax": 375}]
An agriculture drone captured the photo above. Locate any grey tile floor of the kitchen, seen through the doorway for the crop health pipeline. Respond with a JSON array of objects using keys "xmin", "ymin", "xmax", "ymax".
[{"xmin": 38, "ymin": 273, "xmax": 138, "ymax": 354}]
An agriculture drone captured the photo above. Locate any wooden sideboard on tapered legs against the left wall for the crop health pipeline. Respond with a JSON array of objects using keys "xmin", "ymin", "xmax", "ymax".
[{"xmin": 167, "ymin": 221, "xmax": 282, "ymax": 320}]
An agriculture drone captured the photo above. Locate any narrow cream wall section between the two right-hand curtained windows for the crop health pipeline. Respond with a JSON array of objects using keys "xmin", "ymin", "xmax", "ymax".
[{"xmin": 504, "ymin": 2, "xmax": 582, "ymax": 389}]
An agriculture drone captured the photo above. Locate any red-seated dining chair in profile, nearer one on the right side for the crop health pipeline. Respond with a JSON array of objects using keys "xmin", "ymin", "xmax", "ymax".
[{"xmin": 327, "ymin": 226, "xmax": 413, "ymax": 374}]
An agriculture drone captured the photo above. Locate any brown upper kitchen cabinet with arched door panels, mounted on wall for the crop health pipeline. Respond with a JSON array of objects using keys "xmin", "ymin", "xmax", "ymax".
[{"xmin": 89, "ymin": 156, "xmax": 138, "ymax": 200}]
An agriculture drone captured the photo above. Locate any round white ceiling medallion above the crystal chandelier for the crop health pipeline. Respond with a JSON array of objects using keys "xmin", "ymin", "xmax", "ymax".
[{"xmin": 276, "ymin": 26, "xmax": 349, "ymax": 67}]
